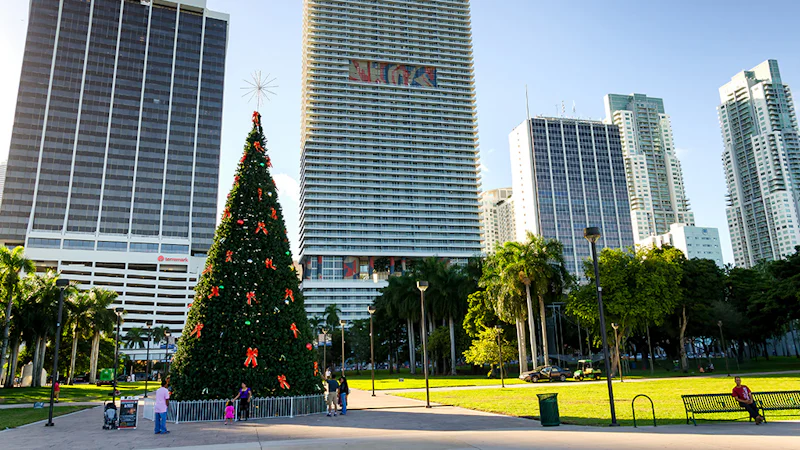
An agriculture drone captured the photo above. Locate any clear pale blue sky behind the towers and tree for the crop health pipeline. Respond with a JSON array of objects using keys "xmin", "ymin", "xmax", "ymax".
[{"xmin": 0, "ymin": 0, "xmax": 800, "ymax": 262}]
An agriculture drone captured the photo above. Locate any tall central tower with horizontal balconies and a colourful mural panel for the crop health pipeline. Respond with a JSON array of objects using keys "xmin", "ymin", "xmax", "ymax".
[{"xmin": 300, "ymin": 0, "xmax": 481, "ymax": 320}]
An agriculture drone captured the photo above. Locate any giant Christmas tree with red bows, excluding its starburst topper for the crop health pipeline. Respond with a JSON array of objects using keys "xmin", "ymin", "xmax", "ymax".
[{"xmin": 171, "ymin": 112, "xmax": 321, "ymax": 400}]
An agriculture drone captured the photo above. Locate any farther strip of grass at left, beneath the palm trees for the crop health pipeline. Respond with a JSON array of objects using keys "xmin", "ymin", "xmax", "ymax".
[{"xmin": 0, "ymin": 381, "xmax": 149, "ymax": 405}]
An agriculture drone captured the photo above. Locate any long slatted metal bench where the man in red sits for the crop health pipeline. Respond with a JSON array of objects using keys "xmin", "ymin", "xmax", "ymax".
[{"xmin": 681, "ymin": 391, "xmax": 800, "ymax": 426}]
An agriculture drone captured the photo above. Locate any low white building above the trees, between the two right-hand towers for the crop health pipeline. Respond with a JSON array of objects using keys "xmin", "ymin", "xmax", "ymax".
[{"xmin": 638, "ymin": 223, "xmax": 725, "ymax": 268}]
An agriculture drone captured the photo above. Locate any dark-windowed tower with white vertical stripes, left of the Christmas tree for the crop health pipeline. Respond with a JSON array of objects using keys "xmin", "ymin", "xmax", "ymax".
[{"xmin": 0, "ymin": 0, "xmax": 228, "ymax": 348}]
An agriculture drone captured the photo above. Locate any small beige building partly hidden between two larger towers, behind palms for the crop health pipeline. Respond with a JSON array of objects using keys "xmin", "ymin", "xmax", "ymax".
[{"xmin": 481, "ymin": 188, "xmax": 517, "ymax": 253}]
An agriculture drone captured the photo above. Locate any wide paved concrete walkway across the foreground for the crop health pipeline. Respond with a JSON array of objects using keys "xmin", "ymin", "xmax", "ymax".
[{"xmin": 0, "ymin": 390, "xmax": 800, "ymax": 450}]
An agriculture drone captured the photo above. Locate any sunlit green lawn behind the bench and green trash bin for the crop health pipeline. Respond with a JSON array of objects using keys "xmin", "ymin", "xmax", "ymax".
[{"xmin": 399, "ymin": 375, "xmax": 800, "ymax": 425}]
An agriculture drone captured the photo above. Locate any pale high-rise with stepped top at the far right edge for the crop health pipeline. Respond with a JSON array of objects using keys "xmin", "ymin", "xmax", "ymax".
[{"xmin": 717, "ymin": 60, "xmax": 800, "ymax": 267}]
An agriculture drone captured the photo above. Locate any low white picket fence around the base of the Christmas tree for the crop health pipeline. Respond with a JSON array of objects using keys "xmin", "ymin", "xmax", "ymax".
[{"xmin": 139, "ymin": 394, "xmax": 326, "ymax": 423}]
